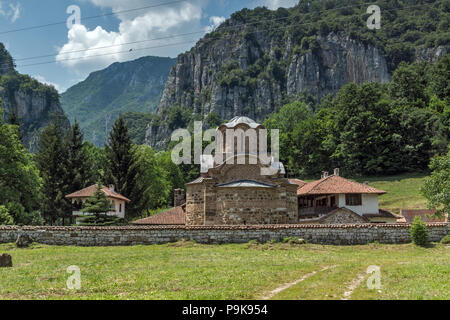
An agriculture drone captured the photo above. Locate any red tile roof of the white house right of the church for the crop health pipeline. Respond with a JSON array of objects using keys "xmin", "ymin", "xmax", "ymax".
[{"xmin": 297, "ymin": 175, "xmax": 386, "ymax": 195}]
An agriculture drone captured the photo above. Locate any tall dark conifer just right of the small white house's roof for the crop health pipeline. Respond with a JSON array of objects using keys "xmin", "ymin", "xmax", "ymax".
[{"xmin": 105, "ymin": 116, "xmax": 144, "ymax": 219}]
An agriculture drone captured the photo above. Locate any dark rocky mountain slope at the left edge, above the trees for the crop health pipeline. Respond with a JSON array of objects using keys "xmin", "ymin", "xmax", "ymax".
[{"xmin": 0, "ymin": 43, "xmax": 70, "ymax": 152}]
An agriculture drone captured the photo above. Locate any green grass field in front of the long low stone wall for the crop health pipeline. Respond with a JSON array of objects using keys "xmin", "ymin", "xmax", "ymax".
[{"xmin": 0, "ymin": 242, "xmax": 450, "ymax": 300}]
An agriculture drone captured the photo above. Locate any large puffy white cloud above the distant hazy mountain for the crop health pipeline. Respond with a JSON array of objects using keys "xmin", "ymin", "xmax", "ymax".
[{"xmin": 56, "ymin": 0, "xmax": 207, "ymax": 75}]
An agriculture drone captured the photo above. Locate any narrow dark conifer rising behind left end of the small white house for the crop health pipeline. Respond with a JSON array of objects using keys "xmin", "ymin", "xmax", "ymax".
[{"xmin": 66, "ymin": 120, "xmax": 93, "ymax": 224}]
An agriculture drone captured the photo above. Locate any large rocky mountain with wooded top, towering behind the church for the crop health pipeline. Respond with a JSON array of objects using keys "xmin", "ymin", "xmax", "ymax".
[{"xmin": 146, "ymin": 0, "xmax": 450, "ymax": 148}]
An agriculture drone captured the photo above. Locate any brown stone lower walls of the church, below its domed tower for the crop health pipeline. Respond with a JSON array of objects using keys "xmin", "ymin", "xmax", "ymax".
[{"xmin": 186, "ymin": 160, "xmax": 298, "ymax": 226}]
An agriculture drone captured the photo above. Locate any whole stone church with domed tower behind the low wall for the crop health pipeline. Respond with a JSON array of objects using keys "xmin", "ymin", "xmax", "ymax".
[{"xmin": 186, "ymin": 117, "xmax": 298, "ymax": 226}]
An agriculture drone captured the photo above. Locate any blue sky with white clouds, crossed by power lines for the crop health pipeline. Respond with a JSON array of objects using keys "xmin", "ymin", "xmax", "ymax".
[{"xmin": 0, "ymin": 0, "xmax": 298, "ymax": 93}]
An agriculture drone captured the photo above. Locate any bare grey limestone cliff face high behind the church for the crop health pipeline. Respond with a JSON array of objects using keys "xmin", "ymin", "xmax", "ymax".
[{"xmin": 147, "ymin": 33, "xmax": 390, "ymax": 147}]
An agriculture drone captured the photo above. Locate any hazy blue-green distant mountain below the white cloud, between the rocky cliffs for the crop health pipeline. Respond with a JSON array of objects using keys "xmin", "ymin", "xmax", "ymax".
[{"xmin": 61, "ymin": 56, "xmax": 176, "ymax": 146}]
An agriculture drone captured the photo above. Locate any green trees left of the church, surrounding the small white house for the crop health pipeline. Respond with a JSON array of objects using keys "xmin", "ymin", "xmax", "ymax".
[{"xmin": 0, "ymin": 109, "xmax": 186, "ymax": 225}]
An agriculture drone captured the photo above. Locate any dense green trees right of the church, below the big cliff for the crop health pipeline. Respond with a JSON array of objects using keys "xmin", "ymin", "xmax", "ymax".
[{"xmin": 264, "ymin": 55, "xmax": 450, "ymax": 177}]
